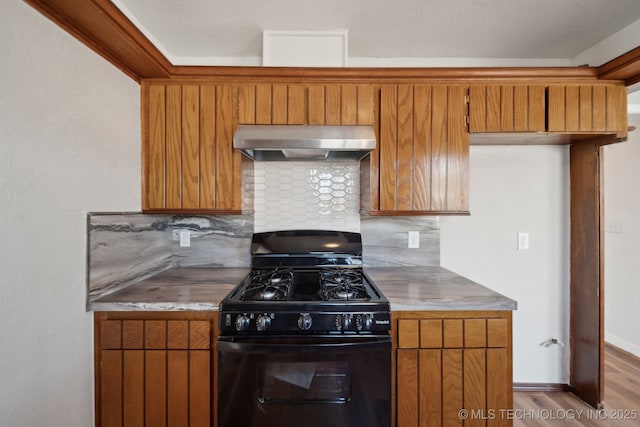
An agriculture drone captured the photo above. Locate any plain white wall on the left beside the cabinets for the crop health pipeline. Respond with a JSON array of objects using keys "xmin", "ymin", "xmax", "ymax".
[{"xmin": 0, "ymin": 1, "xmax": 140, "ymax": 427}]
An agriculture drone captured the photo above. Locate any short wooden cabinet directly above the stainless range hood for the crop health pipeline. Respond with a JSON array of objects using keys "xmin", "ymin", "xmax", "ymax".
[{"xmin": 238, "ymin": 84, "xmax": 375, "ymax": 125}]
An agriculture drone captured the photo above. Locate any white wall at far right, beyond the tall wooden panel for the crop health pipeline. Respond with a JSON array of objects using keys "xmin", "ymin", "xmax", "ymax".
[{"xmin": 604, "ymin": 115, "xmax": 640, "ymax": 357}]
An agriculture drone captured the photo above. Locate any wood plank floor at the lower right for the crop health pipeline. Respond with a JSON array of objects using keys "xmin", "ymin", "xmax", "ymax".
[{"xmin": 513, "ymin": 344, "xmax": 640, "ymax": 427}]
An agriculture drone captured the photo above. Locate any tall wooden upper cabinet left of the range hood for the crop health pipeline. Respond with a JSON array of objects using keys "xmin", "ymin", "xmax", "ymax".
[{"xmin": 142, "ymin": 82, "xmax": 242, "ymax": 213}]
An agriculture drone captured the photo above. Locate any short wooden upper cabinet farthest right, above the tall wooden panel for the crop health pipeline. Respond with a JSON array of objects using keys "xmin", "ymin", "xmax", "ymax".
[{"xmin": 548, "ymin": 83, "xmax": 627, "ymax": 136}]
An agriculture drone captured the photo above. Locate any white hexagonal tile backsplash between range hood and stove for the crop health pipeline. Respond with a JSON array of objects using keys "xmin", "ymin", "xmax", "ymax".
[{"xmin": 253, "ymin": 161, "xmax": 360, "ymax": 232}]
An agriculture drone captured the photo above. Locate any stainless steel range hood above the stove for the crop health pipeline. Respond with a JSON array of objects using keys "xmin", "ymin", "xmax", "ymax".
[{"xmin": 233, "ymin": 125, "xmax": 376, "ymax": 161}]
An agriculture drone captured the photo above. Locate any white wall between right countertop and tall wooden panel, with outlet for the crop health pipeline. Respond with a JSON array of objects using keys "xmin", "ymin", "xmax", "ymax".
[{"xmin": 440, "ymin": 146, "xmax": 569, "ymax": 383}]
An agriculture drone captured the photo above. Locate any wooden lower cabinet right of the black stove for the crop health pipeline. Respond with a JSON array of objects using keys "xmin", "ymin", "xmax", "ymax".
[{"xmin": 392, "ymin": 311, "xmax": 513, "ymax": 427}]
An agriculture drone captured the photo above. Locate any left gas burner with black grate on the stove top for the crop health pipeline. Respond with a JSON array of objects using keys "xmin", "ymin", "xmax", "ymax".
[{"xmin": 240, "ymin": 269, "xmax": 293, "ymax": 301}]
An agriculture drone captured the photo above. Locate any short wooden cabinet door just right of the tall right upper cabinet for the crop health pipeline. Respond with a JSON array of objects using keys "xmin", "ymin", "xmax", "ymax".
[{"xmin": 469, "ymin": 85, "xmax": 546, "ymax": 132}]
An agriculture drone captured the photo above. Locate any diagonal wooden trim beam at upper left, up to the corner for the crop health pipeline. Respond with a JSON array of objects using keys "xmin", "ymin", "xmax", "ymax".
[{"xmin": 24, "ymin": 0, "xmax": 172, "ymax": 82}]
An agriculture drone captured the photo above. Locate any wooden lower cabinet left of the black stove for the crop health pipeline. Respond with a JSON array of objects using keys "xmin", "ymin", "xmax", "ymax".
[{"xmin": 95, "ymin": 312, "xmax": 217, "ymax": 427}]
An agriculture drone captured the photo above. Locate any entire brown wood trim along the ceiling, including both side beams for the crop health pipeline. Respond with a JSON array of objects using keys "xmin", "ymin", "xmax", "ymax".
[{"xmin": 24, "ymin": 0, "xmax": 640, "ymax": 86}]
